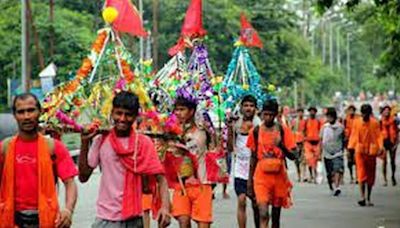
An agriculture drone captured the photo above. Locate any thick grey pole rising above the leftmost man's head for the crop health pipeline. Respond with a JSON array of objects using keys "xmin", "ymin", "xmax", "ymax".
[{"xmin": 21, "ymin": 0, "xmax": 30, "ymax": 92}]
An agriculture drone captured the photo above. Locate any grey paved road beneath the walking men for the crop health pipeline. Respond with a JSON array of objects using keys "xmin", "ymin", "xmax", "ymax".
[{"xmin": 62, "ymin": 150, "xmax": 400, "ymax": 228}]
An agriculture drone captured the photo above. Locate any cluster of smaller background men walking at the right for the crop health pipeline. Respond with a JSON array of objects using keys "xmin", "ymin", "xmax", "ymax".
[{"xmin": 291, "ymin": 104, "xmax": 399, "ymax": 206}]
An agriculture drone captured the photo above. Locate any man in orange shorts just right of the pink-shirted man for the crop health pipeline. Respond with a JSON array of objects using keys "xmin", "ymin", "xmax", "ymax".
[{"xmin": 172, "ymin": 92, "xmax": 217, "ymax": 227}]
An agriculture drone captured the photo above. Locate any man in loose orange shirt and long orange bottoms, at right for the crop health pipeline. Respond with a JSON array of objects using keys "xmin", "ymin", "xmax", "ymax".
[{"xmin": 349, "ymin": 104, "xmax": 384, "ymax": 207}]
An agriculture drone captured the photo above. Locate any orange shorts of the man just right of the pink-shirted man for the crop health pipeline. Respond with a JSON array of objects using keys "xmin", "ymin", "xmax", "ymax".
[{"xmin": 172, "ymin": 185, "xmax": 213, "ymax": 223}]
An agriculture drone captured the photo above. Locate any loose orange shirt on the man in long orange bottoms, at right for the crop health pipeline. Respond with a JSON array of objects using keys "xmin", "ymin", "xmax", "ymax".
[{"xmin": 349, "ymin": 117, "xmax": 383, "ymax": 153}]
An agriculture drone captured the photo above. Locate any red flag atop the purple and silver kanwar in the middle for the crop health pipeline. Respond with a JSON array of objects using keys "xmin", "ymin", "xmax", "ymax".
[{"xmin": 181, "ymin": 0, "xmax": 207, "ymax": 37}]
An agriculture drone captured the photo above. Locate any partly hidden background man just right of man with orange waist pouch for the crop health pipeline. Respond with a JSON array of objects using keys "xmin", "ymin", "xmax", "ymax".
[{"xmin": 291, "ymin": 108, "xmax": 306, "ymax": 182}]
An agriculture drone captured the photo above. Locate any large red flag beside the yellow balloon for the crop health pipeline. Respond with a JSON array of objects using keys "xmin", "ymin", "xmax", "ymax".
[{"xmin": 106, "ymin": 0, "xmax": 147, "ymax": 36}]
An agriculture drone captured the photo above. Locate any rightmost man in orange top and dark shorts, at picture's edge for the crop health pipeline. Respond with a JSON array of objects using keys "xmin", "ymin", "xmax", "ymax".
[{"xmin": 380, "ymin": 105, "xmax": 399, "ymax": 186}]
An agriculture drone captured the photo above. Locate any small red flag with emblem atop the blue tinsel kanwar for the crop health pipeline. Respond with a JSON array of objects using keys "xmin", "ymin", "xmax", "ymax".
[{"xmin": 240, "ymin": 13, "xmax": 263, "ymax": 48}]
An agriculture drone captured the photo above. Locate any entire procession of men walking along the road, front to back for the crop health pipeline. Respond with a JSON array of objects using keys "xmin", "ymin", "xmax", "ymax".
[{"xmin": 0, "ymin": 92, "xmax": 398, "ymax": 228}]
